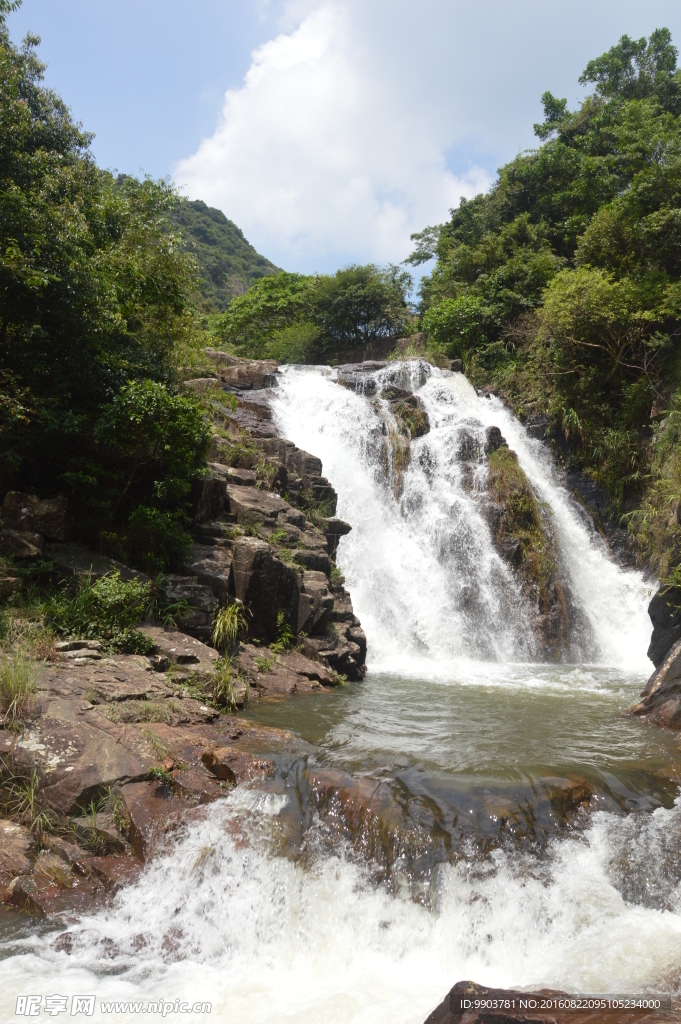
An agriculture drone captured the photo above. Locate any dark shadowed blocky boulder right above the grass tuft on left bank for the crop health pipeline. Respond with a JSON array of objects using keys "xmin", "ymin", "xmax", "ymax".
[{"xmin": 231, "ymin": 537, "xmax": 300, "ymax": 640}]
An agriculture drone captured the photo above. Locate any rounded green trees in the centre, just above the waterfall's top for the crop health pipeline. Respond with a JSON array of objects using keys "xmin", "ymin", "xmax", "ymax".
[{"xmin": 215, "ymin": 264, "xmax": 411, "ymax": 362}]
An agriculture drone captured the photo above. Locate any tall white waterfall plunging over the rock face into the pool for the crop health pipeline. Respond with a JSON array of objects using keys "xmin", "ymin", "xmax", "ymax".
[{"xmin": 273, "ymin": 360, "xmax": 651, "ymax": 676}]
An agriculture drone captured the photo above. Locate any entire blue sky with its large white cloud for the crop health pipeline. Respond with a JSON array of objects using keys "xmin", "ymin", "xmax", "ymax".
[{"xmin": 7, "ymin": 0, "xmax": 681, "ymax": 272}]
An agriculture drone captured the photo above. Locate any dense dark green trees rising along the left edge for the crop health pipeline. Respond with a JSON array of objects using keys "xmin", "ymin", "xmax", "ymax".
[{"xmin": 0, "ymin": 25, "xmax": 207, "ymax": 564}]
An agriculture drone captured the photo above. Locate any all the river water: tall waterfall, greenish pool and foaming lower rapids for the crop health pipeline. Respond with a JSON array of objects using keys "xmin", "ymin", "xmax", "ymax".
[{"xmin": 0, "ymin": 362, "xmax": 681, "ymax": 1024}]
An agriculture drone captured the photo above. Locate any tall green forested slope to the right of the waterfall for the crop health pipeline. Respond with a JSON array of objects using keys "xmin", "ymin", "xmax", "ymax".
[{"xmin": 411, "ymin": 29, "xmax": 681, "ymax": 575}]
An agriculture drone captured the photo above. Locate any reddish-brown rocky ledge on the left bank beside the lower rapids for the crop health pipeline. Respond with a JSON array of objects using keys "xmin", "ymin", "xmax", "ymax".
[{"xmin": 0, "ymin": 627, "xmax": 348, "ymax": 915}]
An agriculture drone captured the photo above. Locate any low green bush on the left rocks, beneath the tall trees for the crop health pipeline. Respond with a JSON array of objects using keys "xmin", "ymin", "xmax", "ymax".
[{"xmin": 46, "ymin": 570, "xmax": 154, "ymax": 654}]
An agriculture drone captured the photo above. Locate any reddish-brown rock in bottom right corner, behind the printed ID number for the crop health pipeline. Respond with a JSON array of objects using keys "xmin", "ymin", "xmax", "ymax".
[{"xmin": 425, "ymin": 981, "xmax": 667, "ymax": 1024}]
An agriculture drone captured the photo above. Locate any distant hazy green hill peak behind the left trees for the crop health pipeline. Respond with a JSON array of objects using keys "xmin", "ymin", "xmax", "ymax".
[{"xmin": 171, "ymin": 199, "xmax": 278, "ymax": 312}]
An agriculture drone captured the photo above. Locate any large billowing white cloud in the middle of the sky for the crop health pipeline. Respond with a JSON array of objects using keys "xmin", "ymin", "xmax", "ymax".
[{"xmin": 175, "ymin": 2, "xmax": 490, "ymax": 270}]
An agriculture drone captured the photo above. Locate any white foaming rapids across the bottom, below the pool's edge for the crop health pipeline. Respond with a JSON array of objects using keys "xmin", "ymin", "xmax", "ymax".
[{"xmin": 5, "ymin": 794, "xmax": 681, "ymax": 1024}]
